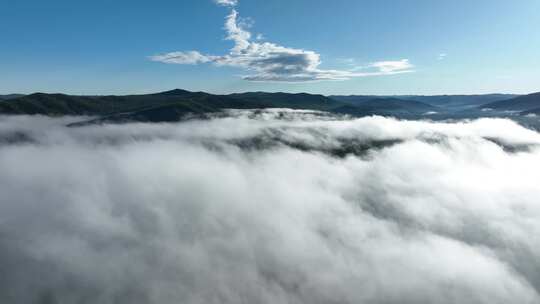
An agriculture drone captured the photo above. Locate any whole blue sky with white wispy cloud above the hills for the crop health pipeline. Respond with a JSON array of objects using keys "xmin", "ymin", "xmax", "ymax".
[{"xmin": 0, "ymin": 0, "xmax": 540, "ymax": 95}]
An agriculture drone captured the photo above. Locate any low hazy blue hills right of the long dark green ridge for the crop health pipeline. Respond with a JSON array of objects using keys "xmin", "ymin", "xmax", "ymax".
[{"xmin": 330, "ymin": 94, "xmax": 518, "ymax": 110}]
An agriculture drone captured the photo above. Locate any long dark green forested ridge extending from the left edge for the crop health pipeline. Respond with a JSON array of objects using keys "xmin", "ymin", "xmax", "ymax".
[{"xmin": 0, "ymin": 89, "xmax": 344, "ymax": 121}]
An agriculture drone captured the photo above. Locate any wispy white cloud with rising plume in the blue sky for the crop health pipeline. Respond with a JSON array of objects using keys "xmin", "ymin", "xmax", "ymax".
[{"xmin": 150, "ymin": 0, "xmax": 414, "ymax": 82}]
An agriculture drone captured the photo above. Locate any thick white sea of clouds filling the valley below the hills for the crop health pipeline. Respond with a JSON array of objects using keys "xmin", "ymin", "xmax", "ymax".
[{"xmin": 0, "ymin": 110, "xmax": 540, "ymax": 304}]
